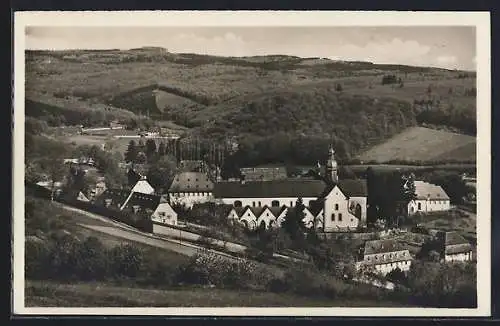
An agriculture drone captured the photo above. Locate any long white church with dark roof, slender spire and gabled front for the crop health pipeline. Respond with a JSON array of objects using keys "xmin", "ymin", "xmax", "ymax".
[{"xmin": 221, "ymin": 148, "xmax": 368, "ymax": 232}]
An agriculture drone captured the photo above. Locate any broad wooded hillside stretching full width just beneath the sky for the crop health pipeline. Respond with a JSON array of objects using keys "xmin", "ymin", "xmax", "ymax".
[{"xmin": 26, "ymin": 47, "xmax": 476, "ymax": 156}]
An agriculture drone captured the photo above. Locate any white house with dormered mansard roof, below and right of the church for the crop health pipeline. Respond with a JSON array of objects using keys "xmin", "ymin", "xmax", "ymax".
[{"xmin": 356, "ymin": 239, "xmax": 413, "ymax": 275}]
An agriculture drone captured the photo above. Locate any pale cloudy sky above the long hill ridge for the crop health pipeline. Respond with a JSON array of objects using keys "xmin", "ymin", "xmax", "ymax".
[{"xmin": 25, "ymin": 26, "xmax": 476, "ymax": 70}]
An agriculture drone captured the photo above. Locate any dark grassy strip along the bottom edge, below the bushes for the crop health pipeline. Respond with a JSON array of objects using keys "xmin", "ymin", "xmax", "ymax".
[{"xmin": 25, "ymin": 281, "xmax": 412, "ymax": 307}]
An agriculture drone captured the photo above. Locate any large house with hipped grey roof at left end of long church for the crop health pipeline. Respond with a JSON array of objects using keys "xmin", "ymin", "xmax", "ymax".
[{"xmin": 168, "ymin": 172, "xmax": 214, "ymax": 208}]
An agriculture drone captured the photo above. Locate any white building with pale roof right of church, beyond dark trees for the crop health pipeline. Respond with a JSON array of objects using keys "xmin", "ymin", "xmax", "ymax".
[{"xmin": 408, "ymin": 181, "xmax": 450, "ymax": 215}]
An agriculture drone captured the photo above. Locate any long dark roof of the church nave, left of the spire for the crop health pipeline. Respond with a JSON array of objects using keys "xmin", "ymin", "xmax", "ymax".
[{"xmin": 214, "ymin": 179, "xmax": 326, "ymax": 198}]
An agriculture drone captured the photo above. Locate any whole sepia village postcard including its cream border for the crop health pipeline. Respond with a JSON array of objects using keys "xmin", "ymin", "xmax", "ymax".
[{"xmin": 12, "ymin": 11, "xmax": 491, "ymax": 317}]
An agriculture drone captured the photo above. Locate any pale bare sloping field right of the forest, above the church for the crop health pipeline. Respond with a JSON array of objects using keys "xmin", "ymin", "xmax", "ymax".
[{"xmin": 359, "ymin": 127, "xmax": 476, "ymax": 163}]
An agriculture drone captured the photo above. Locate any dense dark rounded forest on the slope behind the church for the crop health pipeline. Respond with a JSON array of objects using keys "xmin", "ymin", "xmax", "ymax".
[{"xmin": 201, "ymin": 87, "xmax": 416, "ymax": 159}]
